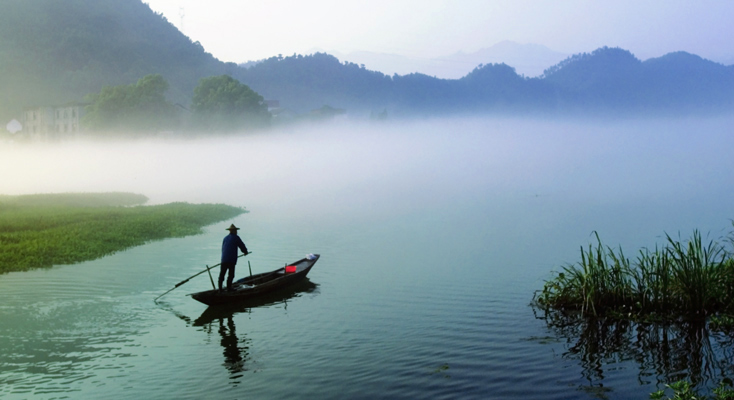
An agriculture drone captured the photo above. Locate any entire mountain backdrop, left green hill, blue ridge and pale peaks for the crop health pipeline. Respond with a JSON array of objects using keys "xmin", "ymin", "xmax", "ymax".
[{"xmin": 0, "ymin": 0, "xmax": 734, "ymax": 125}]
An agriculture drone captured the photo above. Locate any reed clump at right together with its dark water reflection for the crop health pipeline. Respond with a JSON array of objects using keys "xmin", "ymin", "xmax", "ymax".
[{"xmin": 533, "ymin": 227, "xmax": 734, "ymax": 399}]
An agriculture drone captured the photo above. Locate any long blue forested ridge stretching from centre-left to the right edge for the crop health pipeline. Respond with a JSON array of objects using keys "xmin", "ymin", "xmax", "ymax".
[{"xmin": 238, "ymin": 47, "xmax": 734, "ymax": 114}]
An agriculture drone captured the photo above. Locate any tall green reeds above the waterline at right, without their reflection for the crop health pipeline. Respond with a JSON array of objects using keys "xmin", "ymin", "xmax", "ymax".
[{"xmin": 534, "ymin": 231, "xmax": 734, "ymax": 321}]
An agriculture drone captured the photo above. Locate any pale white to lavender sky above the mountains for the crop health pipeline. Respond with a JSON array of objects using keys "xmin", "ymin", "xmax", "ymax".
[{"xmin": 144, "ymin": 0, "xmax": 734, "ymax": 64}]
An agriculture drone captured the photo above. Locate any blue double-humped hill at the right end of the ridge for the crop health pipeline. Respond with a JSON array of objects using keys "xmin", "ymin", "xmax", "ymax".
[{"xmin": 542, "ymin": 48, "xmax": 734, "ymax": 112}]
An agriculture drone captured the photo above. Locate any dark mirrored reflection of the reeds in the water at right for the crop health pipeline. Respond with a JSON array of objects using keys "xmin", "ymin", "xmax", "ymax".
[{"xmin": 536, "ymin": 313, "xmax": 734, "ymax": 388}]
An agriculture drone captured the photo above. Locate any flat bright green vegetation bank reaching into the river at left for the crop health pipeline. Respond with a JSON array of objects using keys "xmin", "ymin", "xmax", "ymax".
[{"xmin": 0, "ymin": 193, "xmax": 246, "ymax": 273}]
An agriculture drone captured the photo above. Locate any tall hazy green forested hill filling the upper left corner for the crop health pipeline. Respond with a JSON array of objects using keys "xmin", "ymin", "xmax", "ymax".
[{"xmin": 0, "ymin": 0, "xmax": 236, "ymax": 120}]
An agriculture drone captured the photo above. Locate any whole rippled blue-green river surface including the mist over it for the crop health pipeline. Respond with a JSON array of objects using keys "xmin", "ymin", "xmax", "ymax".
[{"xmin": 0, "ymin": 118, "xmax": 734, "ymax": 399}]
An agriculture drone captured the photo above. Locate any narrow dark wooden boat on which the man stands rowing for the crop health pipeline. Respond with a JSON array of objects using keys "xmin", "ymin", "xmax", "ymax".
[{"xmin": 189, "ymin": 254, "xmax": 320, "ymax": 306}]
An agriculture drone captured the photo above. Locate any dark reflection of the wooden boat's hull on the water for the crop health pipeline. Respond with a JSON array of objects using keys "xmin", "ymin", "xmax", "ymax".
[{"xmin": 193, "ymin": 278, "xmax": 318, "ymax": 326}]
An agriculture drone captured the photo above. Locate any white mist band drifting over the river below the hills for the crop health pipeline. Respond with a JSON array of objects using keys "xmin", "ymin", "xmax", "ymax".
[{"xmin": 0, "ymin": 114, "xmax": 734, "ymax": 236}]
